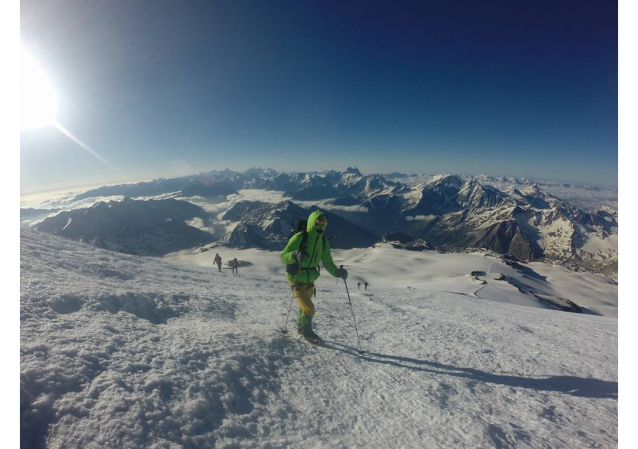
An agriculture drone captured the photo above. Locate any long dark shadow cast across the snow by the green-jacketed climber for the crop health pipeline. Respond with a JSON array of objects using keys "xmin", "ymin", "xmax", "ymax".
[{"xmin": 324, "ymin": 342, "xmax": 618, "ymax": 399}]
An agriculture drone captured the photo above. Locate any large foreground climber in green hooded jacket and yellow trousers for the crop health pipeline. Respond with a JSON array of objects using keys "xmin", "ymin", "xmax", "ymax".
[{"xmin": 281, "ymin": 210, "xmax": 348, "ymax": 341}]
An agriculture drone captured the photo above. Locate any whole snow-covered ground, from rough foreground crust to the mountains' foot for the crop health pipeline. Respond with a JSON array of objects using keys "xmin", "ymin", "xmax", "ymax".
[{"xmin": 20, "ymin": 230, "xmax": 618, "ymax": 448}]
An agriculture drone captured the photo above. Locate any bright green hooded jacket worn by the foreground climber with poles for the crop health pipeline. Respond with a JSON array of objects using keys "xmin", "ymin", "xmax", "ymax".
[{"xmin": 281, "ymin": 210, "xmax": 337, "ymax": 283}]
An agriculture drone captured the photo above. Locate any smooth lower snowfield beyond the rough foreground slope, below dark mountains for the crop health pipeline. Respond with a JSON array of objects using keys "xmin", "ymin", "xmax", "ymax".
[{"xmin": 165, "ymin": 243, "xmax": 618, "ymax": 317}]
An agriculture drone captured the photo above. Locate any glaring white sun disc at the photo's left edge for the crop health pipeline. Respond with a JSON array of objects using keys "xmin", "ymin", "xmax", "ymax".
[{"xmin": 20, "ymin": 48, "xmax": 58, "ymax": 130}]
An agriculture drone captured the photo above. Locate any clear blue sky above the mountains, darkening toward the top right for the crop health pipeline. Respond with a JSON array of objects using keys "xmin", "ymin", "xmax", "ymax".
[{"xmin": 20, "ymin": 0, "xmax": 618, "ymax": 192}]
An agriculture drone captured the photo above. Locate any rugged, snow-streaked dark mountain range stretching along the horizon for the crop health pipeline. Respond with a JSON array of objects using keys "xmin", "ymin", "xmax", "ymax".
[{"xmin": 26, "ymin": 167, "xmax": 618, "ymax": 276}]
